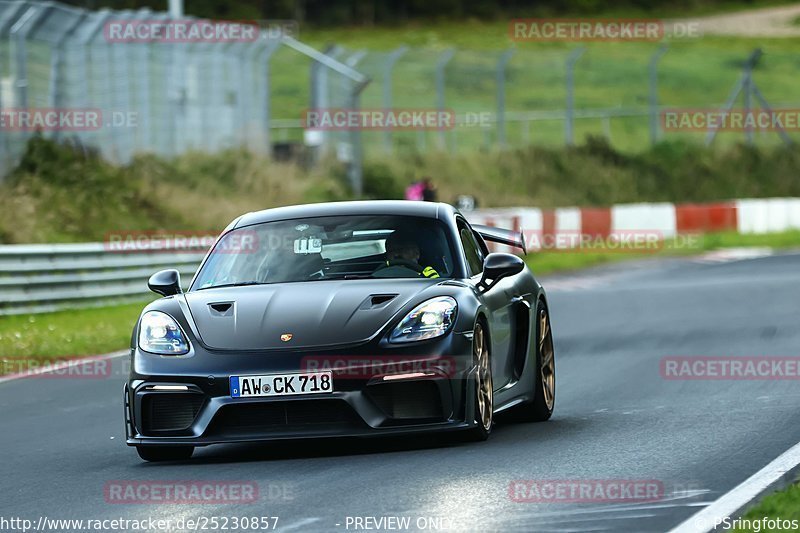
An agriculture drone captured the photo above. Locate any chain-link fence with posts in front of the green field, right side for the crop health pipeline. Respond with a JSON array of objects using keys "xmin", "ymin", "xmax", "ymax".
[{"xmin": 300, "ymin": 42, "xmax": 800, "ymax": 154}]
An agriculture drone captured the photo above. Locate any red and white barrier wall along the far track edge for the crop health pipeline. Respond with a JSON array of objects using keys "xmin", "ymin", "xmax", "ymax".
[{"xmin": 465, "ymin": 198, "xmax": 800, "ymax": 252}]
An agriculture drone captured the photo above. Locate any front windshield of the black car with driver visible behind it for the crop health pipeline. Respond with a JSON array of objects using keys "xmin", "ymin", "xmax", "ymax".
[{"xmin": 192, "ymin": 215, "xmax": 454, "ymax": 289}]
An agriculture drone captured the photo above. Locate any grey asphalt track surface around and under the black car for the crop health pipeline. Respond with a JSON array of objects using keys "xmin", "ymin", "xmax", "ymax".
[{"xmin": 0, "ymin": 253, "xmax": 800, "ymax": 531}]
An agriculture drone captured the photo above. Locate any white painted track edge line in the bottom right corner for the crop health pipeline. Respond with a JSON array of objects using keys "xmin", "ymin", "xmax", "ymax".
[{"xmin": 669, "ymin": 443, "xmax": 800, "ymax": 533}]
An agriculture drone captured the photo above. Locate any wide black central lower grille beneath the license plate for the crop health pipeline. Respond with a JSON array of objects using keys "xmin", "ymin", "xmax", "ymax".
[{"xmin": 207, "ymin": 400, "xmax": 364, "ymax": 435}]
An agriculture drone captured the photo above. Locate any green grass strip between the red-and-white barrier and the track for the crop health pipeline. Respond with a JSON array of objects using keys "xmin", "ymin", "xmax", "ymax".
[{"xmin": 525, "ymin": 231, "xmax": 800, "ymax": 275}]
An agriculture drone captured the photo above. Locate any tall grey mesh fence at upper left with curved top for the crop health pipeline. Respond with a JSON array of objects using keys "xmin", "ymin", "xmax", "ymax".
[{"xmin": 0, "ymin": 0, "xmax": 367, "ymax": 189}]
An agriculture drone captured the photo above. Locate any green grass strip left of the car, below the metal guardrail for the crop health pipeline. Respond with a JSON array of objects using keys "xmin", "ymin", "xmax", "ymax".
[{"xmin": 0, "ymin": 300, "xmax": 152, "ymax": 373}]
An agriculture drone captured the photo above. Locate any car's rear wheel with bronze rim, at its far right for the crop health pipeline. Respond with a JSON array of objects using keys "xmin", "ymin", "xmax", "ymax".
[{"xmin": 514, "ymin": 301, "xmax": 556, "ymax": 422}]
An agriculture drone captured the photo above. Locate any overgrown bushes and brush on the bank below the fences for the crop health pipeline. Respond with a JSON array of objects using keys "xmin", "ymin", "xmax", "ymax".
[{"xmin": 0, "ymin": 137, "xmax": 800, "ymax": 242}]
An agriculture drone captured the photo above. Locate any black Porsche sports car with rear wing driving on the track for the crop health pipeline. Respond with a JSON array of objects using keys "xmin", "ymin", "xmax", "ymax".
[{"xmin": 125, "ymin": 201, "xmax": 555, "ymax": 461}]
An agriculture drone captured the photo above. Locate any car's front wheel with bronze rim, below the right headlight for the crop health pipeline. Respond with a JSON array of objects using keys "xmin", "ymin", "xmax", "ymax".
[{"xmin": 464, "ymin": 322, "xmax": 494, "ymax": 442}]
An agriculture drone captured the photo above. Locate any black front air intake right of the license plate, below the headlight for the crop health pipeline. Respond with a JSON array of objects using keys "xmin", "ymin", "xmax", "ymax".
[{"xmin": 367, "ymin": 380, "xmax": 443, "ymax": 420}]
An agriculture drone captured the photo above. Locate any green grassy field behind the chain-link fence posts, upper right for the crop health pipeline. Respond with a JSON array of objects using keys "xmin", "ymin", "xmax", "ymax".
[{"xmin": 272, "ymin": 22, "xmax": 800, "ymax": 152}]
